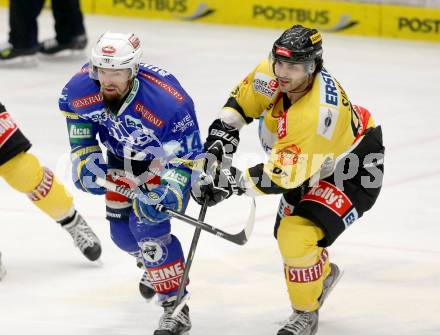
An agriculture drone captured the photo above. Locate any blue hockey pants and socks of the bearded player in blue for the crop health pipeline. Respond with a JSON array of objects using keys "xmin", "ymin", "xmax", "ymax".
[{"xmin": 106, "ymin": 153, "xmax": 188, "ymax": 300}]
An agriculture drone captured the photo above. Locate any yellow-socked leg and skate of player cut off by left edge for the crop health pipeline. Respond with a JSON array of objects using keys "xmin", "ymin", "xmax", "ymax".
[{"xmin": 0, "ymin": 103, "xmax": 101, "ymax": 279}]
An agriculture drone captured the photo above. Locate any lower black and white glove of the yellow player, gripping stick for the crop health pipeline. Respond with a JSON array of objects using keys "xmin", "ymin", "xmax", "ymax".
[{"xmin": 191, "ymin": 166, "xmax": 246, "ymax": 206}]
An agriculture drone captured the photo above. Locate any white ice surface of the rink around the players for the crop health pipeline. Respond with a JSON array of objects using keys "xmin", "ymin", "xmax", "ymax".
[{"xmin": 0, "ymin": 9, "xmax": 440, "ymax": 335}]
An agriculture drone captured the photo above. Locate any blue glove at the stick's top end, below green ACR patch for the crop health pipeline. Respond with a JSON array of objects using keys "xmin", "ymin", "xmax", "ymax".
[{"xmin": 71, "ymin": 145, "xmax": 107, "ymax": 195}]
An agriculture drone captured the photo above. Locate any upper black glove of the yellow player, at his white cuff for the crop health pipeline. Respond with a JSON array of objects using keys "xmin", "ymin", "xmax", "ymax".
[{"xmin": 203, "ymin": 119, "xmax": 240, "ymax": 162}]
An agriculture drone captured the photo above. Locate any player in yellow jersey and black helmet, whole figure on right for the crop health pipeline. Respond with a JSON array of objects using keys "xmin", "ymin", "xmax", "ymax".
[{"xmin": 192, "ymin": 25, "xmax": 384, "ymax": 335}]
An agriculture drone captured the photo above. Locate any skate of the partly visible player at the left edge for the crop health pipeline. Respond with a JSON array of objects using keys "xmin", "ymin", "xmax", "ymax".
[{"xmin": 60, "ymin": 212, "xmax": 101, "ymax": 261}]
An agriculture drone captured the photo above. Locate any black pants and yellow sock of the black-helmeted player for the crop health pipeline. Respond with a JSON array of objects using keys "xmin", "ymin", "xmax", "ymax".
[{"xmin": 275, "ymin": 127, "xmax": 385, "ymax": 311}]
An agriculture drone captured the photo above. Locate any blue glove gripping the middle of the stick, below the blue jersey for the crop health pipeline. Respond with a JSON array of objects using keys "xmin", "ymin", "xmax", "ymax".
[{"xmin": 133, "ymin": 185, "xmax": 183, "ymax": 223}]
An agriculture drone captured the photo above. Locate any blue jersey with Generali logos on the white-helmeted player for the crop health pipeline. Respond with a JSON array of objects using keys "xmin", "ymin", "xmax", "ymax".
[{"xmin": 59, "ymin": 64, "xmax": 202, "ymax": 165}]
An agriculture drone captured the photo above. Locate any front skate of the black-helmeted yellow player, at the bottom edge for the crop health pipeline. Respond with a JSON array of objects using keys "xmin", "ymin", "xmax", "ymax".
[{"xmin": 277, "ymin": 311, "xmax": 319, "ymax": 335}]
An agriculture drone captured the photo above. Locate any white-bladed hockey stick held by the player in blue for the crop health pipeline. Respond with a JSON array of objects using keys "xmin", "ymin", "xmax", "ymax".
[{"xmin": 96, "ymin": 178, "xmax": 256, "ymax": 245}]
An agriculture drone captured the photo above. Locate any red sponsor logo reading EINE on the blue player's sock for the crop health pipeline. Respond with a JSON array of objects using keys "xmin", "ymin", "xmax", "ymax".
[{"xmin": 146, "ymin": 259, "xmax": 185, "ymax": 294}]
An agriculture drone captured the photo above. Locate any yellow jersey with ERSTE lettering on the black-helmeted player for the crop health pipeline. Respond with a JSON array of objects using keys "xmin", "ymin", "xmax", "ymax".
[{"xmin": 220, "ymin": 60, "xmax": 374, "ymax": 195}]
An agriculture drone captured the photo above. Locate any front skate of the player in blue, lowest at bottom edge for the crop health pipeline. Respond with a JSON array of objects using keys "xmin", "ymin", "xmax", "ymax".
[{"xmin": 154, "ymin": 297, "xmax": 191, "ymax": 335}]
